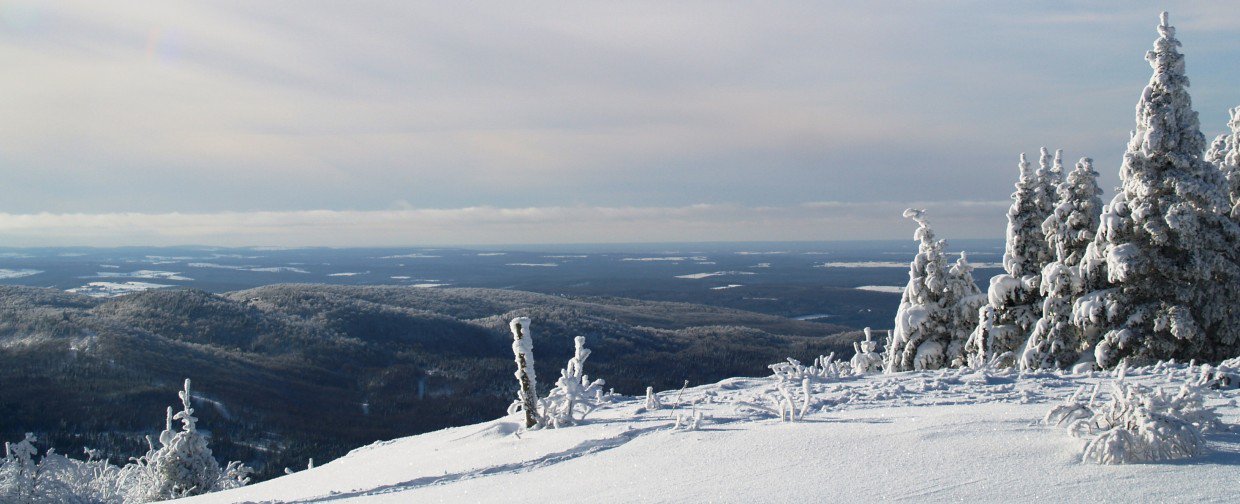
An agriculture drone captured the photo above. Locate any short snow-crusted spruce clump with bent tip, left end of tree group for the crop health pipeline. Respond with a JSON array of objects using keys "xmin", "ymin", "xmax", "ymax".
[{"xmin": 883, "ymin": 209, "xmax": 980, "ymax": 372}]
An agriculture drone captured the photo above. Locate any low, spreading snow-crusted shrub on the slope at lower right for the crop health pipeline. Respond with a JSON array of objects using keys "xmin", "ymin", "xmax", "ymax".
[{"xmin": 1045, "ymin": 379, "xmax": 1223, "ymax": 464}]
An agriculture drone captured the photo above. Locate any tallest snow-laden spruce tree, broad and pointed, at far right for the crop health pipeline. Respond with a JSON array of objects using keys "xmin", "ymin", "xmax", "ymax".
[{"xmin": 1073, "ymin": 12, "xmax": 1240, "ymax": 367}]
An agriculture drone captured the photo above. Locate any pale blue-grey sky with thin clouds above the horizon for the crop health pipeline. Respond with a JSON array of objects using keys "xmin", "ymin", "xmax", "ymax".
[{"xmin": 0, "ymin": 0, "xmax": 1240, "ymax": 246}]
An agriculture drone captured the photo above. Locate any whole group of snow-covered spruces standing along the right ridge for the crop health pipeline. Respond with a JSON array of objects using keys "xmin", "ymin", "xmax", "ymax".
[{"xmin": 887, "ymin": 12, "xmax": 1240, "ymax": 371}]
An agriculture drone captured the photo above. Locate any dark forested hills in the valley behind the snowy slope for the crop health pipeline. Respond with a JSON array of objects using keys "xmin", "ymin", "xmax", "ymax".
[{"xmin": 0, "ymin": 284, "xmax": 857, "ymax": 478}]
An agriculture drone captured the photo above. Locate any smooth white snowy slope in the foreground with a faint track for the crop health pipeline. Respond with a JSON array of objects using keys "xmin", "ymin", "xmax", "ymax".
[{"xmin": 185, "ymin": 366, "xmax": 1240, "ymax": 503}]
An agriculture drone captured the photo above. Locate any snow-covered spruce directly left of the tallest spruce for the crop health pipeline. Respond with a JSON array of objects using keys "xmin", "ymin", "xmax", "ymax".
[{"xmin": 1021, "ymin": 155, "xmax": 1102, "ymax": 369}]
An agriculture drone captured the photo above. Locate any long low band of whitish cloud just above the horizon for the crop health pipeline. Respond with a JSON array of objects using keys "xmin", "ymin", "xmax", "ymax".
[{"xmin": 0, "ymin": 201, "xmax": 1007, "ymax": 247}]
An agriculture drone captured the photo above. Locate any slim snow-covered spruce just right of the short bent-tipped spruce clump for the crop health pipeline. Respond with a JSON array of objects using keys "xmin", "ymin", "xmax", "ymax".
[{"xmin": 970, "ymin": 148, "xmax": 1054, "ymax": 365}]
